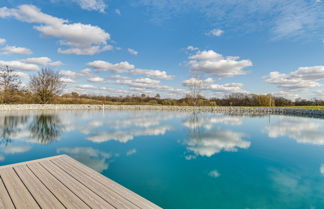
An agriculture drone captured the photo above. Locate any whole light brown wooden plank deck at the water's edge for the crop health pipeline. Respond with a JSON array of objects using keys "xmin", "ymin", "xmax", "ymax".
[{"xmin": 0, "ymin": 155, "xmax": 159, "ymax": 209}]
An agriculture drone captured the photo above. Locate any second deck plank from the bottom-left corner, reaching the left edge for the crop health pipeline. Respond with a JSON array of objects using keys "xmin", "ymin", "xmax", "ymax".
[{"xmin": 0, "ymin": 168, "xmax": 40, "ymax": 209}]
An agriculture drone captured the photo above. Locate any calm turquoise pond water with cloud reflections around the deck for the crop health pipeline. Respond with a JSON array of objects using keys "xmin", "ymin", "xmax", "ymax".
[{"xmin": 0, "ymin": 111, "xmax": 324, "ymax": 209}]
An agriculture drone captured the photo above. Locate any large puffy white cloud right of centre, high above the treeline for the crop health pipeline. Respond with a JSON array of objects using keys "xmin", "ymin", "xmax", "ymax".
[{"xmin": 188, "ymin": 50, "xmax": 252, "ymax": 77}]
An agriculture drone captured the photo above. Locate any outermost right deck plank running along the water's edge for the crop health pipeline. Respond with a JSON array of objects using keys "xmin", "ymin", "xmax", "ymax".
[{"xmin": 60, "ymin": 156, "xmax": 160, "ymax": 209}]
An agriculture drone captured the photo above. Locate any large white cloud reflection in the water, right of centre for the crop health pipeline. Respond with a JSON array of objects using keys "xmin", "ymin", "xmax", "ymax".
[{"xmin": 183, "ymin": 113, "xmax": 251, "ymax": 159}]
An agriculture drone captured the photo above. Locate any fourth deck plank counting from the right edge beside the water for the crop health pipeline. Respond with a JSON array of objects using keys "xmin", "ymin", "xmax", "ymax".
[{"xmin": 27, "ymin": 162, "xmax": 90, "ymax": 209}]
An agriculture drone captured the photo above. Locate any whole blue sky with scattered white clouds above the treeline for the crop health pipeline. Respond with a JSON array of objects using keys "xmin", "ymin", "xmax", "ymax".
[{"xmin": 0, "ymin": 0, "xmax": 324, "ymax": 99}]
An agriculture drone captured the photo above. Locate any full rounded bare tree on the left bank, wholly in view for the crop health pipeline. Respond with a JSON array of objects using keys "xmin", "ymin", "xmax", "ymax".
[{"xmin": 29, "ymin": 68, "xmax": 65, "ymax": 104}]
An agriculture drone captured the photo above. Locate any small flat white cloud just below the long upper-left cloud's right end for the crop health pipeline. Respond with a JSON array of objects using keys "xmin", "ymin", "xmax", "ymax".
[{"xmin": 87, "ymin": 60, "xmax": 135, "ymax": 73}]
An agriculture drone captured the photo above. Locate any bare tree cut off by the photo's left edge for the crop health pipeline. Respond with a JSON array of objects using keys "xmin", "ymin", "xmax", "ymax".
[{"xmin": 0, "ymin": 66, "xmax": 21, "ymax": 103}]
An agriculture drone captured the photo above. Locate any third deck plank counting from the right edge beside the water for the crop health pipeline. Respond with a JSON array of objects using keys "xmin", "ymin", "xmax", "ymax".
[{"xmin": 40, "ymin": 161, "xmax": 114, "ymax": 209}]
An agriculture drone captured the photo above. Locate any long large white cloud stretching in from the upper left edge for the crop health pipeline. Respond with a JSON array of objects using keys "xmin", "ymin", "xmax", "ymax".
[{"xmin": 0, "ymin": 5, "xmax": 112, "ymax": 55}]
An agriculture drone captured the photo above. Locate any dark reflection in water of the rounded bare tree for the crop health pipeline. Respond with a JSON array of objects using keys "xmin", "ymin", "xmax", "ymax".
[{"xmin": 29, "ymin": 114, "xmax": 63, "ymax": 144}]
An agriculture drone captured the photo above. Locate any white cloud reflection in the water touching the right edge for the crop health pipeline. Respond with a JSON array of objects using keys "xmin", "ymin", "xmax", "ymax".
[{"xmin": 265, "ymin": 117, "xmax": 324, "ymax": 145}]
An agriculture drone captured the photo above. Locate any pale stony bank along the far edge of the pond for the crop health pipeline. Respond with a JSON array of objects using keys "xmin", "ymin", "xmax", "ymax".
[{"xmin": 0, "ymin": 104, "xmax": 324, "ymax": 116}]
